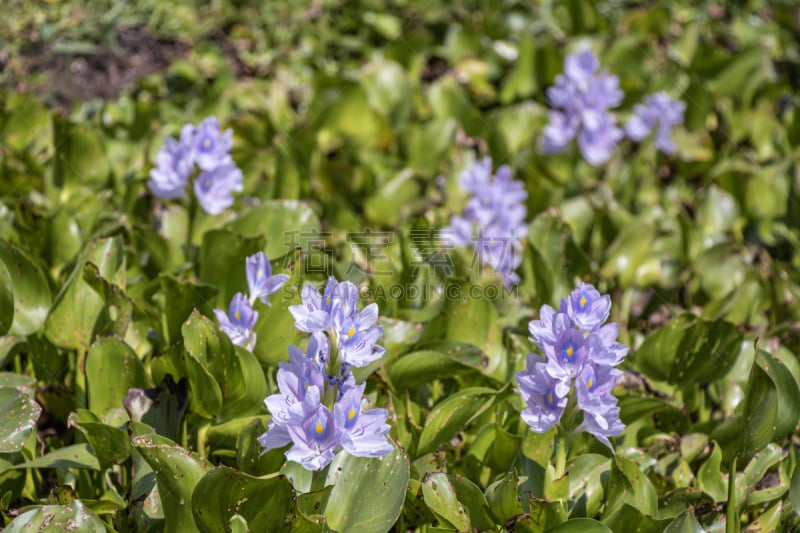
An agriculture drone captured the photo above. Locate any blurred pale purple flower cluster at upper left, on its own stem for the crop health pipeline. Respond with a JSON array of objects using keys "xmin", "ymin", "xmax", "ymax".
[{"xmin": 147, "ymin": 117, "xmax": 244, "ymax": 215}]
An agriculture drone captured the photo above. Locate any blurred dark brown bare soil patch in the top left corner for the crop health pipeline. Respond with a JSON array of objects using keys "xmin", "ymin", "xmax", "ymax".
[{"xmin": 2, "ymin": 28, "xmax": 190, "ymax": 107}]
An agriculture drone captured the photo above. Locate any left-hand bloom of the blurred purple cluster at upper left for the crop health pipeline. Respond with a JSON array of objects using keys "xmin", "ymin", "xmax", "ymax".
[{"xmin": 147, "ymin": 124, "xmax": 194, "ymax": 199}]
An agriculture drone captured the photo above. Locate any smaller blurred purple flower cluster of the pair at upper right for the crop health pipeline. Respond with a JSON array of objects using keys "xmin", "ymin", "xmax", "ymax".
[{"xmin": 625, "ymin": 92, "xmax": 686, "ymax": 154}]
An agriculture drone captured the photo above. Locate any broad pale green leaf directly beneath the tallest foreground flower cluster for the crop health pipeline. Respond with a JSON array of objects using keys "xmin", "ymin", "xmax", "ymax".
[{"xmin": 324, "ymin": 448, "xmax": 410, "ymax": 533}]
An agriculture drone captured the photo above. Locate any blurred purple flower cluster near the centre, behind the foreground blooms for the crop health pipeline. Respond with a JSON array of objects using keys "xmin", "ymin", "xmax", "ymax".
[{"xmin": 442, "ymin": 157, "xmax": 528, "ymax": 285}]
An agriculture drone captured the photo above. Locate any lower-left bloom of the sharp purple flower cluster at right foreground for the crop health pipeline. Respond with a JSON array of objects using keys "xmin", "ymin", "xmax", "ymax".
[{"xmin": 516, "ymin": 354, "xmax": 569, "ymax": 433}]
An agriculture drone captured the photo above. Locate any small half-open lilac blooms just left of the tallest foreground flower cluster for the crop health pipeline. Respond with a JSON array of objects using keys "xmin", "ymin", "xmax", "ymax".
[{"xmin": 214, "ymin": 252, "xmax": 289, "ymax": 352}]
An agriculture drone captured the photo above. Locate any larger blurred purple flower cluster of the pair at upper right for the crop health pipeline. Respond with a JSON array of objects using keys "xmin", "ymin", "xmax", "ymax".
[{"xmin": 541, "ymin": 49, "xmax": 624, "ymax": 165}]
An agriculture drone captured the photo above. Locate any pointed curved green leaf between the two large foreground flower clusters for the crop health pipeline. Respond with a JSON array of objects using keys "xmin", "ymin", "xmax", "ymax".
[{"xmin": 417, "ymin": 387, "xmax": 498, "ymax": 457}]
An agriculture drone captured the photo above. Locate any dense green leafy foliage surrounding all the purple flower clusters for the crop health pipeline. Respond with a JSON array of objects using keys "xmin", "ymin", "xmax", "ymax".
[{"xmin": 0, "ymin": 0, "xmax": 800, "ymax": 533}]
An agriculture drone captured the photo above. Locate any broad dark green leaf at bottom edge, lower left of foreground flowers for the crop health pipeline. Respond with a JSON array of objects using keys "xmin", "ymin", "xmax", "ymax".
[{"xmin": 192, "ymin": 466, "xmax": 294, "ymax": 533}]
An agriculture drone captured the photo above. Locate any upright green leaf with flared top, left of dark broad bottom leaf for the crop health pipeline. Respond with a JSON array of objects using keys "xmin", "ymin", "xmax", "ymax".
[{"xmin": 131, "ymin": 434, "xmax": 212, "ymax": 532}]
